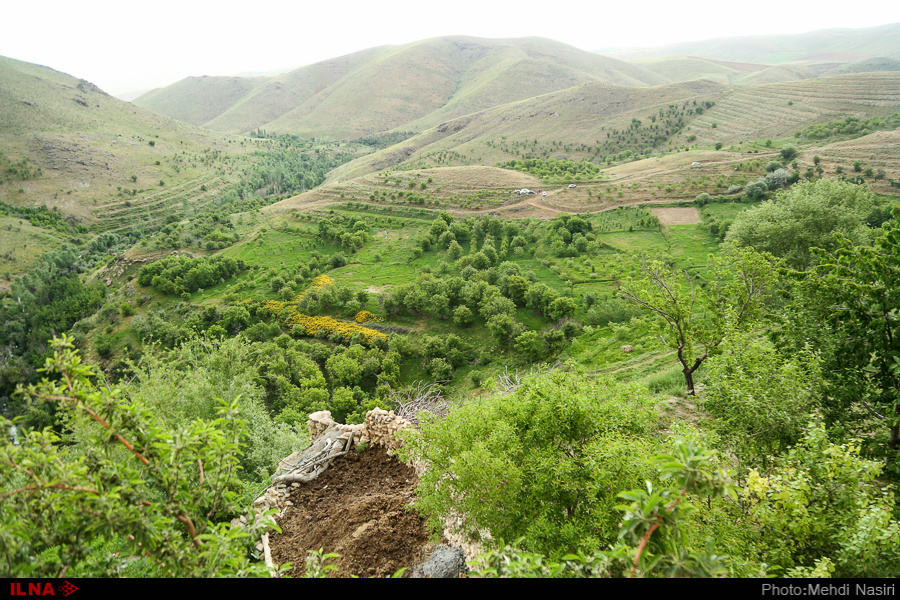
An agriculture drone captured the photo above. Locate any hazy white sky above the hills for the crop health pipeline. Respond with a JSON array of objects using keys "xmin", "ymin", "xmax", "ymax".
[{"xmin": 0, "ymin": 0, "xmax": 900, "ymax": 94}]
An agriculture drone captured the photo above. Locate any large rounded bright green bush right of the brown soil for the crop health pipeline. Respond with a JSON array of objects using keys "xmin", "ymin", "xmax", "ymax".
[{"xmin": 399, "ymin": 371, "xmax": 659, "ymax": 555}]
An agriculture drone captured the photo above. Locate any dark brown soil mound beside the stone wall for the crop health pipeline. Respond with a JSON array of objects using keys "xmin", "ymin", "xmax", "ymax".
[{"xmin": 269, "ymin": 445, "xmax": 429, "ymax": 577}]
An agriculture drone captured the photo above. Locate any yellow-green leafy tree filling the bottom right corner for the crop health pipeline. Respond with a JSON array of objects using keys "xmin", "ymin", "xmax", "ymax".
[{"xmin": 746, "ymin": 420, "xmax": 900, "ymax": 577}]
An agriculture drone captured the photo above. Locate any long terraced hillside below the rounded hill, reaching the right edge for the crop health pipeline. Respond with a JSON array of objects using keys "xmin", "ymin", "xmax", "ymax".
[{"xmin": 318, "ymin": 71, "xmax": 900, "ymax": 181}]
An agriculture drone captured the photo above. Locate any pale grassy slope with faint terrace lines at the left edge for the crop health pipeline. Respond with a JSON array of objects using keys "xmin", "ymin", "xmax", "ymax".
[{"xmin": 0, "ymin": 57, "xmax": 274, "ymax": 282}]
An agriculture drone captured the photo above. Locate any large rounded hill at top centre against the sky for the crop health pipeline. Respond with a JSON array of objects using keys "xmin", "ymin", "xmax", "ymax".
[{"xmin": 135, "ymin": 36, "xmax": 665, "ymax": 139}]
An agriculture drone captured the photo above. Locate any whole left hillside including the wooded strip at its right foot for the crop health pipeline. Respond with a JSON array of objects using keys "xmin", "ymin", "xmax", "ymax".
[{"xmin": 0, "ymin": 57, "xmax": 368, "ymax": 291}]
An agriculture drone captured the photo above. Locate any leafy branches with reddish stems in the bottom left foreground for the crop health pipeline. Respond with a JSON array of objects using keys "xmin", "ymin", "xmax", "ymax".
[{"xmin": 0, "ymin": 335, "xmax": 274, "ymax": 577}]
